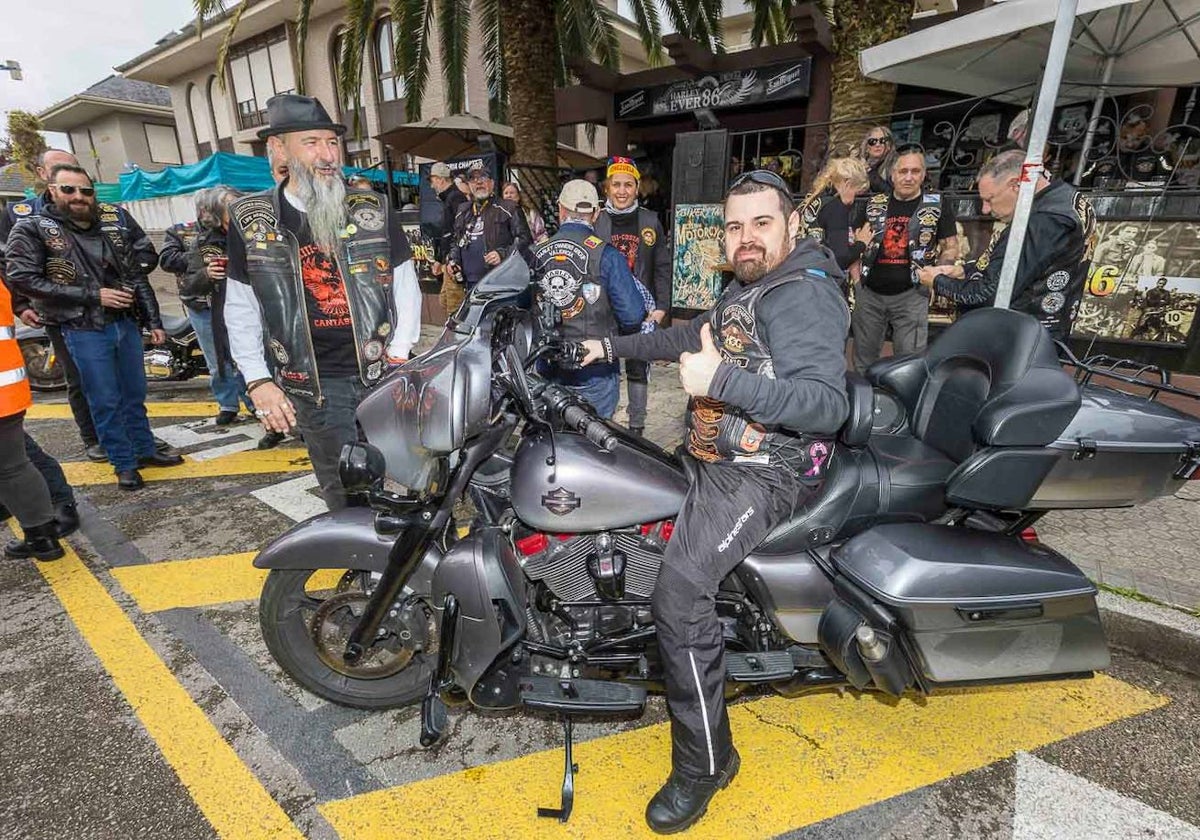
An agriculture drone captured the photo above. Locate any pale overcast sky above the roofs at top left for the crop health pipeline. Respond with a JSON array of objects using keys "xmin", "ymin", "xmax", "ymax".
[{"xmin": 0, "ymin": 0, "xmax": 193, "ymax": 144}]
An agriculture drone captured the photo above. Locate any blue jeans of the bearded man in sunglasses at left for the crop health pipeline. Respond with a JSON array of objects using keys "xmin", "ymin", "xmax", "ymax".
[{"xmin": 62, "ymin": 318, "xmax": 155, "ymax": 473}]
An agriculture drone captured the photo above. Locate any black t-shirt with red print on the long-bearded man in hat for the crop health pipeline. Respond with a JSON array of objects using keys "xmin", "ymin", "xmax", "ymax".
[{"xmin": 228, "ymin": 193, "xmax": 413, "ymax": 377}]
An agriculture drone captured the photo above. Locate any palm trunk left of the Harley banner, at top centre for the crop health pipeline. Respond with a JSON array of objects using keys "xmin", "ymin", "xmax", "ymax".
[{"xmin": 500, "ymin": 0, "xmax": 558, "ymax": 167}]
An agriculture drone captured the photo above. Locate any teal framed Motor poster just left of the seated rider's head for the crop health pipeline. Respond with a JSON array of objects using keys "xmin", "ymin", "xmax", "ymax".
[{"xmin": 671, "ymin": 204, "xmax": 725, "ymax": 310}]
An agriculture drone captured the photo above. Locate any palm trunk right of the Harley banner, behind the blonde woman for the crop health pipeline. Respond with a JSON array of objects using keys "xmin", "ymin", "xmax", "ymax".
[{"xmin": 829, "ymin": 0, "xmax": 912, "ymax": 155}]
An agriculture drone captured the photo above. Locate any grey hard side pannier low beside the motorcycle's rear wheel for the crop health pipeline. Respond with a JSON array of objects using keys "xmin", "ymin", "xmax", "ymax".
[{"xmin": 833, "ymin": 523, "xmax": 1109, "ymax": 684}]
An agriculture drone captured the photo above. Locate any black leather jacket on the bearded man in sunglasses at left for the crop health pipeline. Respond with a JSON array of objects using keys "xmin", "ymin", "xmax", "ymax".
[{"xmin": 5, "ymin": 203, "xmax": 162, "ymax": 329}]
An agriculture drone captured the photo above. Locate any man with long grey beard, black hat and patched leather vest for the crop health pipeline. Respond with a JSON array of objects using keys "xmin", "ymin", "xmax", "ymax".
[{"xmin": 224, "ymin": 94, "xmax": 421, "ymax": 509}]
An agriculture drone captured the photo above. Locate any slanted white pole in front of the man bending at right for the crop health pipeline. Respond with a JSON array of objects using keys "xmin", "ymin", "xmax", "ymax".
[{"xmin": 995, "ymin": 0, "xmax": 1079, "ymax": 310}]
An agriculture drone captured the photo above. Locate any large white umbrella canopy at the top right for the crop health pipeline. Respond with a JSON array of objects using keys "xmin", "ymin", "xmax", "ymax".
[{"xmin": 859, "ymin": 0, "xmax": 1200, "ymax": 104}]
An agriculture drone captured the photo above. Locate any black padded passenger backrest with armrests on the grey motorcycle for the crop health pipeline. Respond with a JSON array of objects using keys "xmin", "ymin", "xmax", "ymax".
[{"xmin": 866, "ymin": 308, "xmax": 1080, "ymax": 461}]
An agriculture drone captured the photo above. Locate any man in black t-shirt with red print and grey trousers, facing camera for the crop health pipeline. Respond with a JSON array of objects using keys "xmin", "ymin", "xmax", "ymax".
[{"xmin": 851, "ymin": 145, "xmax": 959, "ymax": 372}]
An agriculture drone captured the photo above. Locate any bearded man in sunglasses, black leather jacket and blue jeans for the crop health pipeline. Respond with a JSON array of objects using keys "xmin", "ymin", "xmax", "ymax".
[{"xmin": 6, "ymin": 164, "xmax": 184, "ymax": 490}]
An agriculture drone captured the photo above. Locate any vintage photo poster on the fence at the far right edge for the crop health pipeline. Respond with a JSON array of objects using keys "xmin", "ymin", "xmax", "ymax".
[{"xmin": 1072, "ymin": 222, "xmax": 1200, "ymax": 344}]
